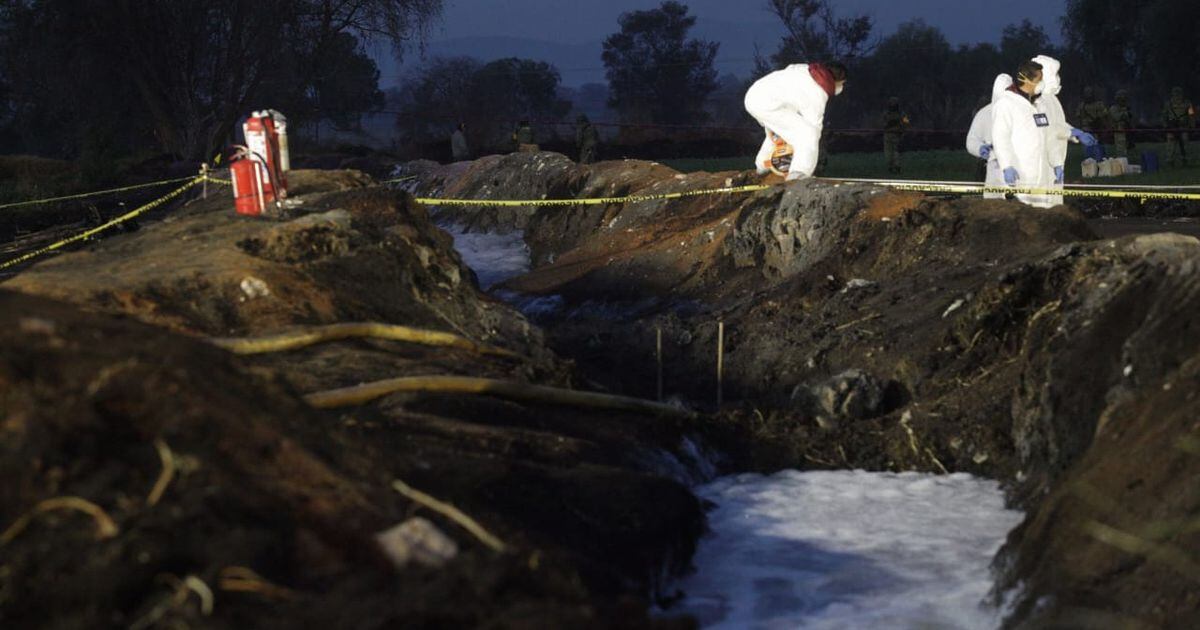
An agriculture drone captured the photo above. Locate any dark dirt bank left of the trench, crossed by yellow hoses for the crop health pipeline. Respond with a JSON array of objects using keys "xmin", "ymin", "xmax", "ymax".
[{"xmin": 0, "ymin": 172, "xmax": 703, "ymax": 628}]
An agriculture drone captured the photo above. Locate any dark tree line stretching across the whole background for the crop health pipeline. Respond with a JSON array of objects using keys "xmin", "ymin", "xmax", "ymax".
[{"xmin": 0, "ymin": 0, "xmax": 1200, "ymax": 164}]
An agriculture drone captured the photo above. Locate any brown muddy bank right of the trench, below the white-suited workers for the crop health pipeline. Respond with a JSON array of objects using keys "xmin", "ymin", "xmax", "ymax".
[{"xmin": 418, "ymin": 155, "xmax": 1200, "ymax": 628}]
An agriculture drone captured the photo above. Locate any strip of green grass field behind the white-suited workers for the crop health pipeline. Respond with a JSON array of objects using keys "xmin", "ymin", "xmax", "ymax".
[{"xmin": 662, "ymin": 143, "xmax": 1200, "ymax": 186}]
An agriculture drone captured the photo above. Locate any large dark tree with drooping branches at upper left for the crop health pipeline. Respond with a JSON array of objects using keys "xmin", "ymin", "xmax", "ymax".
[{"xmin": 0, "ymin": 0, "xmax": 440, "ymax": 160}]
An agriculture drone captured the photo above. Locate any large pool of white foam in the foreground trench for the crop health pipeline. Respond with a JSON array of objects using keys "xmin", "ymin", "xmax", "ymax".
[{"xmin": 668, "ymin": 472, "xmax": 1022, "ymax": 630}]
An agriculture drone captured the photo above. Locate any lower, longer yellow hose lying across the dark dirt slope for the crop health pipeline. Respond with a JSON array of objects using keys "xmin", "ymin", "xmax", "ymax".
[{"xmin": 305, "ymin": 376, "xmax": 694, "ymax": 418}]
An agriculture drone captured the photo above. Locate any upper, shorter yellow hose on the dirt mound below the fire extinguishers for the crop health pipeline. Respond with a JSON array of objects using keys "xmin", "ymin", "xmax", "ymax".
[{"xmin": 209, "ymin": 323, "xmax": 521, "ymax": 359}]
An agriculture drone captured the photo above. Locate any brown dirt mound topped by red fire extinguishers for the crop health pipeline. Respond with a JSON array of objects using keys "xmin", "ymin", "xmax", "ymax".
[{"xmin": 5, "ymin": 172, "xmax": 539, "ymax": 352}]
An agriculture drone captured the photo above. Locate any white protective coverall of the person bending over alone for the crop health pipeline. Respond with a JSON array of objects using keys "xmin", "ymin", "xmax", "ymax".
[{"xmin": 745, "ymin": 64, "xmax": 829, "ymax": 179}]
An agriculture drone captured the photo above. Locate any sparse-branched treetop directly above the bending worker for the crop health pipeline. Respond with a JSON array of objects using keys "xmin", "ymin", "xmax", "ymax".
[{"xmin": 756, "ymin": 0, "xmax": 875, "ymax": 71}]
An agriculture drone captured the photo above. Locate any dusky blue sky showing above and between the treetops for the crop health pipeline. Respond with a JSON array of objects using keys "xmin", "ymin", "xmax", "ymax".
[{"xmin": 377, "ymin": 0, "xmax": 1066, "ymax": 85}]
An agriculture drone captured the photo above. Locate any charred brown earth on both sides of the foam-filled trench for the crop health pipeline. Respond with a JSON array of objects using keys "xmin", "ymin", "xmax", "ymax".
[{"xmin": 0, "ymin": 154, "xmax": 1200, "ymax": 628}]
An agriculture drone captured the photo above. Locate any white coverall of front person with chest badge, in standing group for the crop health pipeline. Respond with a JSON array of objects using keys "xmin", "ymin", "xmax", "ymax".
[{"xmin": 991, "ymin": 73, "xmax": 1054, "ymax": 208}]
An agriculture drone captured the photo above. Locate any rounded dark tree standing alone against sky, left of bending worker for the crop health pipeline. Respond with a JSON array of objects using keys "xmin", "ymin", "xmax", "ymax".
[{"xmin": 602, "ymin": 1, "xmax": 719, "ymax": 124}]
